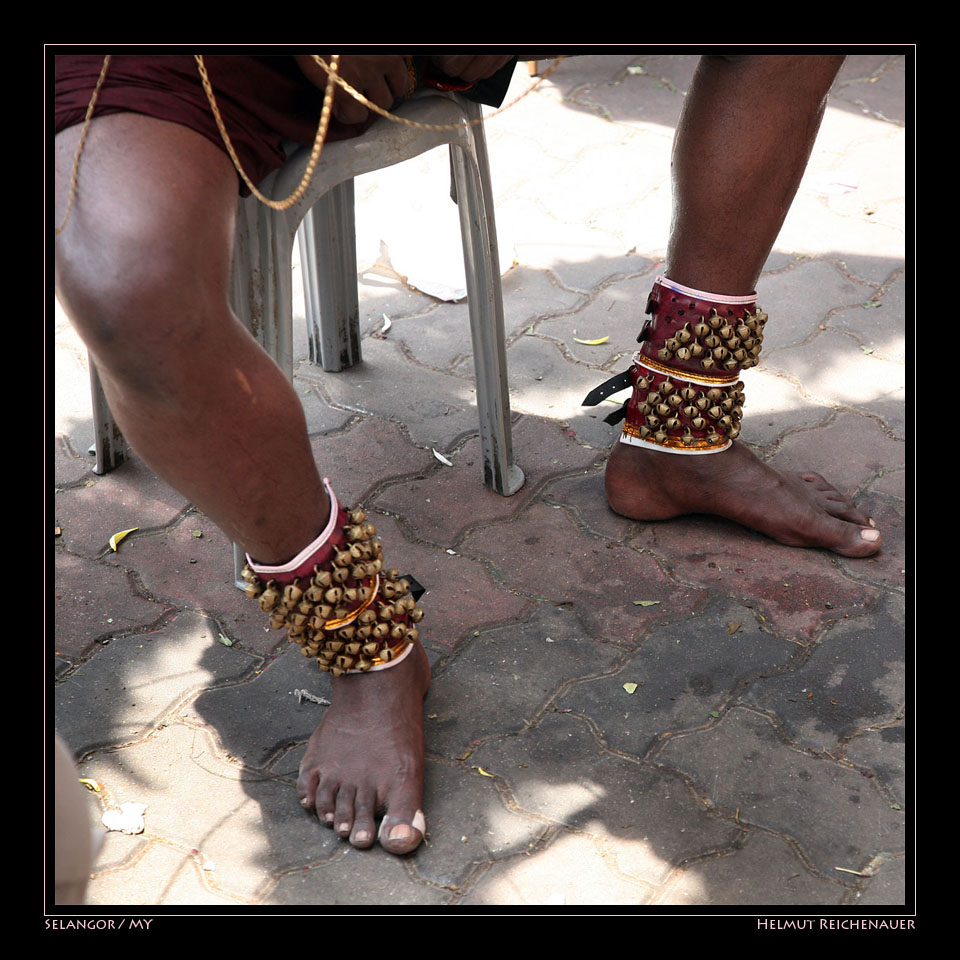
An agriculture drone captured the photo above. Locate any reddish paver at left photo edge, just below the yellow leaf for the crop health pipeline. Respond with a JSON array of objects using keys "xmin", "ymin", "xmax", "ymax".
[{"xmin": 54, "ymin": 548, "xmax": 172, "ymax": 660}]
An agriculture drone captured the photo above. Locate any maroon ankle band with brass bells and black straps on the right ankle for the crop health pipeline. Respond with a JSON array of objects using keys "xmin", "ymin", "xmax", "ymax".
[{"xmin": 584, "ymin": 277, "xmax": 767, "ymax": 454}]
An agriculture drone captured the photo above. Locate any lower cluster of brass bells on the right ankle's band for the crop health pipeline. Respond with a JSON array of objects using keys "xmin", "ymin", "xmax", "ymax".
[{"xmin": 636, "ymin": 376, "xmax": 743, "ymax": 445}]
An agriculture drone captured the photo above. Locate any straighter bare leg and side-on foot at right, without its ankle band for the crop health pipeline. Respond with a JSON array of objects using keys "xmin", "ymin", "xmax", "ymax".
[{"xmin": 606, "ymin": 56, "xmax": 881, "ymax": 556}]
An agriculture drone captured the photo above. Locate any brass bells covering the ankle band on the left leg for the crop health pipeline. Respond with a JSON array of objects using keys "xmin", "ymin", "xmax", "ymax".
[{"xmin": 242, "ymin": 509, "xmax": 423, "ymax": 677}]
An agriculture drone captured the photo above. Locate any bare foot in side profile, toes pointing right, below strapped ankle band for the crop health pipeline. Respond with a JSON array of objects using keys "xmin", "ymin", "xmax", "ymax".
[{"xmin": 606, "ymin": 441, "xmax": 882, "ymax": 557}]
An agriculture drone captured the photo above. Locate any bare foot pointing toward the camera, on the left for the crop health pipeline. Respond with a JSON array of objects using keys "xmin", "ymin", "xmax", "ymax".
[{"xmin": 297, "ymin": 642, "xmax": 430, "ymax": 853}]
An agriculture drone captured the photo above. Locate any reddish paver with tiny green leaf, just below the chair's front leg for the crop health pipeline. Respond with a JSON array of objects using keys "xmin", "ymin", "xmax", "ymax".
[{"xmin": 462, "ymin": 503, "xmax": 703, "ymax": 642}]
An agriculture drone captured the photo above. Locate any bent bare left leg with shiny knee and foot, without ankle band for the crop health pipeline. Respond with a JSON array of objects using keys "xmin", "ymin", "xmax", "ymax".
[{"xmin": 56, "ymin": 114, "xmax": 429, "ymax": 853}]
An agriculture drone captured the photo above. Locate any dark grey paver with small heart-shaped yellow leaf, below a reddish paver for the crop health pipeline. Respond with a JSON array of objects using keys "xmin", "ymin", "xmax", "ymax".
[{"xmin": 557, "ymin": 598, "xmax": 797, "ymax": 757}]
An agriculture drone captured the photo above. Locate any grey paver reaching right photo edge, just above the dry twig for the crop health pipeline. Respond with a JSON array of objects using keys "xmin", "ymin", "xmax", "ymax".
[{"xmin": 657, "ymin": 708, "xmax": 904, "ymax": 877}]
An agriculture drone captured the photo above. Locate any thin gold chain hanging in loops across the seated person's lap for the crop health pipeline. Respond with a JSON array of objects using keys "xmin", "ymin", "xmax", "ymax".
[{"xmin": 56, "ymin": 54, "xmax": 565, "ymax": 226}]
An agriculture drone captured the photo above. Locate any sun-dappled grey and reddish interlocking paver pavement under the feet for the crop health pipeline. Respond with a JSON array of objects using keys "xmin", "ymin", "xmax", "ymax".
[{"xmin": 52, "ymin": 53, "xmax": 912, "ymax": 910}]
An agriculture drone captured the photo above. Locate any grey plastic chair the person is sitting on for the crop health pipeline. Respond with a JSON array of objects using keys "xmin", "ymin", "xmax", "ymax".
[{"xmin": 84, "ymin": 93, "xmax": 524, "ymax": 586}]
